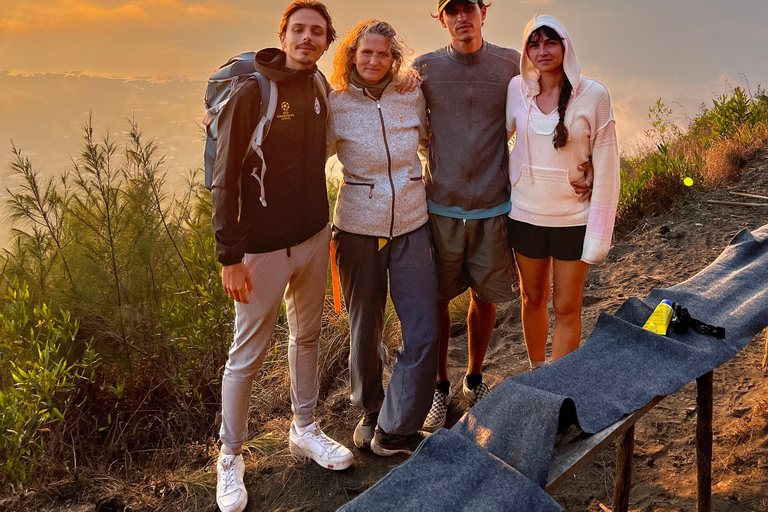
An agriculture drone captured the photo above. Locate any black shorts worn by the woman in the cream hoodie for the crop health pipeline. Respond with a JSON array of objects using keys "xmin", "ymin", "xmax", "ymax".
[{"xmin": 507, "ymin": 219, "xmax": 587, "ymax": 261}]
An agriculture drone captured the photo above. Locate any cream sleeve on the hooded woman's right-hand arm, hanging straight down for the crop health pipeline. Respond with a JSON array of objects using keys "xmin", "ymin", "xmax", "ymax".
[{"xmin": 581, "ymin": 83, "xmax": 620, "ymax": 263}]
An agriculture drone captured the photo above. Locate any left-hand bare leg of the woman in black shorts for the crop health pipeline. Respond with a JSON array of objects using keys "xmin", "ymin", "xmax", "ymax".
[{"xmin": 515, "ymin": 254, "xmax": 552, "ymax": 363}]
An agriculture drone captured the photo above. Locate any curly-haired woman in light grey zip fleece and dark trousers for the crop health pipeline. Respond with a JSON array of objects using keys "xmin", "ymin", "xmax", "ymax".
[{"xmin": 328, "ymin": 20, "xmax": 438, "ymax": 456}]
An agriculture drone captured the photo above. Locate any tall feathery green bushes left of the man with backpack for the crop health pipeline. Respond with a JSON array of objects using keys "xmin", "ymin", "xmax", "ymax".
[{"xmin": 0, "ymin": 114, "xmax": 356, "ymax": 482}]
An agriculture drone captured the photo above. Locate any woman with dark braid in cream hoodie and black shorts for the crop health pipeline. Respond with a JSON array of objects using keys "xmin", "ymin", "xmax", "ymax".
[{"xmin": 507, "ymin": 16, "xmax": 619, "ymax": 368}]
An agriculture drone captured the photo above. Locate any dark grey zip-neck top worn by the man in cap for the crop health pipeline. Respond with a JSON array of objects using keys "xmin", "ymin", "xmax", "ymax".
[{"xmin": 414, "ymin": 41, "xmax": 520, "ymax": 216}]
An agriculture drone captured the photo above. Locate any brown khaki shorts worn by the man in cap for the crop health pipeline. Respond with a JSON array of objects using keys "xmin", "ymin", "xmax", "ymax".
[{"xmin": 429, "ymin": 213, "xmax": 520, "ymax": 302}]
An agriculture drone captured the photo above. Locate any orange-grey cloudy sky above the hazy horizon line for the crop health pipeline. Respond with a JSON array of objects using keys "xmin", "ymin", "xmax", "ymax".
[{"xmin": 0, "ymin": 0, "xmax": 768, "ymax": 152}]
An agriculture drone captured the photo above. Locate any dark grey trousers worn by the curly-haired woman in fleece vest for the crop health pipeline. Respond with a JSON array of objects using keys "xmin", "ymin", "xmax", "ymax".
[{"xmin": 333, "ymin": 225, "xmax": 438, "ymax": 435}]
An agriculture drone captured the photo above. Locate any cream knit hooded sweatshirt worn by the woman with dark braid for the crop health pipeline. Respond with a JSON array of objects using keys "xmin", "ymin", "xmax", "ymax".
[{"xmin": 507, "ymin": 16, "xmax": 619, "ymax": 264}]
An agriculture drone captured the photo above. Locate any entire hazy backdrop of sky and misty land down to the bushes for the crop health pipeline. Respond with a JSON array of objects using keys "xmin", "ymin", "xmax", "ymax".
[{"xmin": 0, "ymin": 0, "xmax": 768, "ymax": 246}]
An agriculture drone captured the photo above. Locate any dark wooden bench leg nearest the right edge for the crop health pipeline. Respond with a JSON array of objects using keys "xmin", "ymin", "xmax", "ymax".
[{"xmin": 696, "ymin": 372, "xmax": 713, "ymax": 512}]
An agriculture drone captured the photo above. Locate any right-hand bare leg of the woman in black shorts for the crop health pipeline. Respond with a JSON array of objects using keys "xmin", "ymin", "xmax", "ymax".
[{"xmin": 552, "ymin": 260, "xmax": 589, "ymax": 361}]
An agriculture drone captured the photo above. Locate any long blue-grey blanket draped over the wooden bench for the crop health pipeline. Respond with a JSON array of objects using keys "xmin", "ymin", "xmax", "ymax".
[{"xmin": 340, "ymin": 225, "xmax": 768, "ymax": 511}]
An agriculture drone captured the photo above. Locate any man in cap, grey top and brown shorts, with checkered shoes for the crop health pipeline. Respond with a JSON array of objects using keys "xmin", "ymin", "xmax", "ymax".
[{"xmin": 414, "ymin": 0, "xmax": 591, "ymax": 431}]
